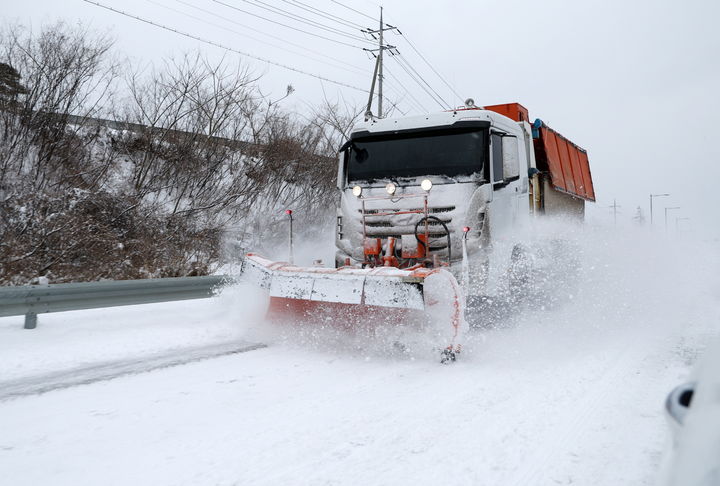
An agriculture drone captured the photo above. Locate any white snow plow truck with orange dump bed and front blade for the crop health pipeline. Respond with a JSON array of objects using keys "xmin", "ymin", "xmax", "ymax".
[{"xmin": 243, "ymin": 99, "xmax": 595, "ymax": 362}]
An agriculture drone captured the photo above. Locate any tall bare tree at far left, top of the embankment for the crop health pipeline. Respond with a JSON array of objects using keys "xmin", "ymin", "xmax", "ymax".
[{"xmin": 0, "ymin": 22, "xmax": 120, "ymax": 190}]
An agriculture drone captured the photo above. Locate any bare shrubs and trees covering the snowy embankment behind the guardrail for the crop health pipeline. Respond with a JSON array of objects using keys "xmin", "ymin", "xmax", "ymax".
[{"xmin": 0, "ymin": 23, "xmax": 368, "ymax": 285}]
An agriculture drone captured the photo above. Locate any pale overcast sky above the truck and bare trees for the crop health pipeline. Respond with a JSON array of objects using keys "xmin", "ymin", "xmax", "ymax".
[{"xmin": 2, "ymin": 0, "xmax": 720, "ymax": 236}]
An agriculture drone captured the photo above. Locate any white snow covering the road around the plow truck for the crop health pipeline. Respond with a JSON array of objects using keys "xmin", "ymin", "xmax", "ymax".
[{"xmin": 0, "ymin": 228, "xmax": 720, "ymax": 485}]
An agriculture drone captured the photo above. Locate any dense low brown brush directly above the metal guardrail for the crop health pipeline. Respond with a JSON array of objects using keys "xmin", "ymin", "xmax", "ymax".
[{"xmin": 0, "ymin": 190, "xmax": 220, "ymax": 284}]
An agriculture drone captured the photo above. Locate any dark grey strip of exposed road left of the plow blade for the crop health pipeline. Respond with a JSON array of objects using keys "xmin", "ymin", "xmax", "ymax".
[{"xmin": 0, "ymin": 342, "xmax": 267, "ymax": 401}]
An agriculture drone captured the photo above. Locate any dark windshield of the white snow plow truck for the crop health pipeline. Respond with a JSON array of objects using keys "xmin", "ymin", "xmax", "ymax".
[{"xmin": 348, "ymin": 128, "xmax": 488, "ymax": 181}]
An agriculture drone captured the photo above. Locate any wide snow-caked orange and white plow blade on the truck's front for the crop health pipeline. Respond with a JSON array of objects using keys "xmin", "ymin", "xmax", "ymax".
[{"xmin": 242, "ymin": 253, "xmax": 467, "ymax": 359}]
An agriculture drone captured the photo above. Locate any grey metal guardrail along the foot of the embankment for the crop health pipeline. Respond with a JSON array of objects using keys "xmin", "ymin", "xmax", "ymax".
[{"xmin": 0, "ymin": 275, "xmax": 233, "ymax": 329}]
